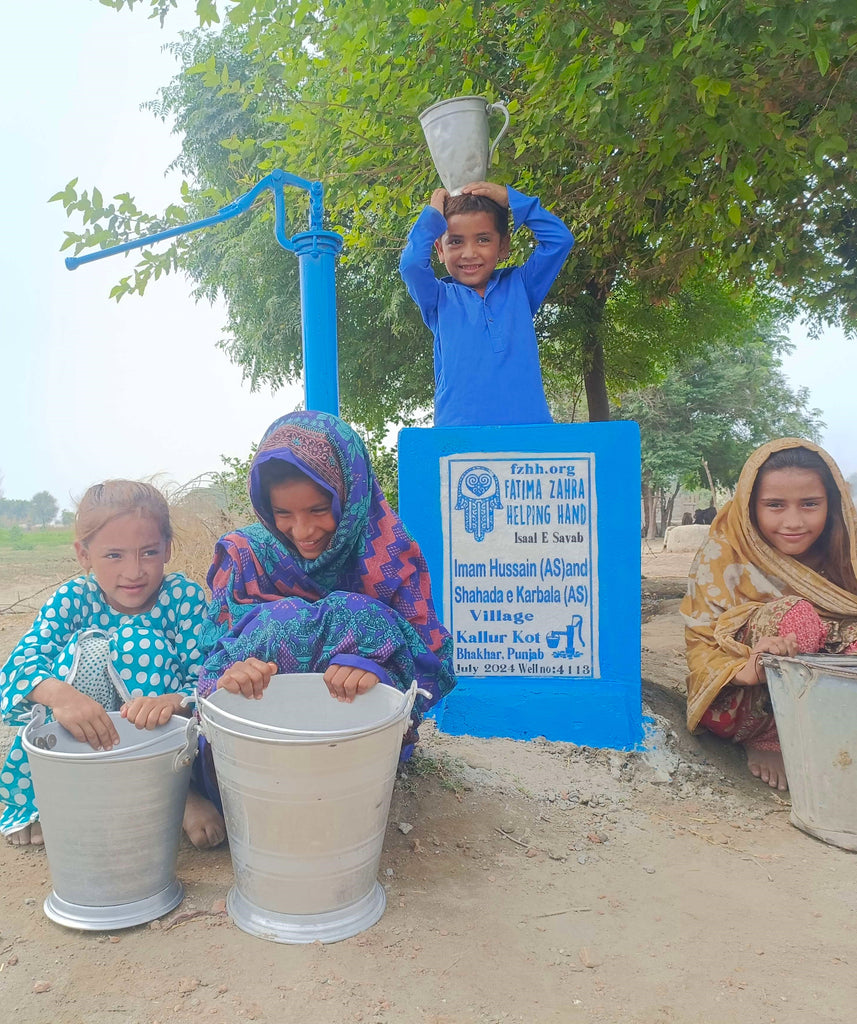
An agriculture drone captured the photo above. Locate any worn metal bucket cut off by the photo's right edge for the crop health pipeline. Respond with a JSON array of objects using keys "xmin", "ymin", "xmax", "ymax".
[{"xmin": 762, "ymin": 654, "xmax": 857, "ymax": 850}]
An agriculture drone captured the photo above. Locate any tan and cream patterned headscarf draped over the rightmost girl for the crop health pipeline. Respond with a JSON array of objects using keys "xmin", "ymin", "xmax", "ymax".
[{"xmin": 681, "ymin": 437, "xmax": 857, "ymax": 729}]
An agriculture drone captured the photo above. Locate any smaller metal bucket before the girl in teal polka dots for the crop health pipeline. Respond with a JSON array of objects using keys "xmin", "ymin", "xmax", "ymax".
[{"xmin": 23, "ymin": 705, "xmax": 199, "ymax": 931}]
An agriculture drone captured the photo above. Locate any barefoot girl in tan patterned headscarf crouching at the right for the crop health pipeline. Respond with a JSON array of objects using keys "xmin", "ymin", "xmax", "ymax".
[{"xmin": 681, "ymin": 437, "xmax": 857, "ymax": 790}]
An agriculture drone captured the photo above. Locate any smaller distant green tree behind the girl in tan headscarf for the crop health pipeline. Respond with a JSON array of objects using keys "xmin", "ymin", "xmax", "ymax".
[{"xmin": 619, "ymin": 318, "xmax": 824, "ymax": 537}]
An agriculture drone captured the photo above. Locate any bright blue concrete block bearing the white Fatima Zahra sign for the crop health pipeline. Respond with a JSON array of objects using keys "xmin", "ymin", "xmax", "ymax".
[{"xmin": 398, "ymin": 422, "xmax": 643, "ymax": 750}]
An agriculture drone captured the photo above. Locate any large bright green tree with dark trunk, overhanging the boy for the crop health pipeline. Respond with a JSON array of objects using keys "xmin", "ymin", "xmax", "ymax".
[{"xmin": 78, "ymin": 0, "xmax": 857, "ymax": 419}]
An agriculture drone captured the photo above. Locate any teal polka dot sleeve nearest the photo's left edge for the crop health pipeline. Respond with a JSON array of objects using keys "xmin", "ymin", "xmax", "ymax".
[{"xmin": 0, "ymin": 578, "xmax": 88, "ymax": 724}]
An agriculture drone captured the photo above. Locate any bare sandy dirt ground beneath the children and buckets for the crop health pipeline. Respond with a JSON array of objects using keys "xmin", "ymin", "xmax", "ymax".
[{"xmin": 0, "ymin": 546, "xmax": 857, "ymax": 1024}]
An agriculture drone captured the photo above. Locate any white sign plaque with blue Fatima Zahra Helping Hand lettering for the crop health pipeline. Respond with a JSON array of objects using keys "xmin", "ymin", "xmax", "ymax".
[{"xmin": 440, "ymin": 453, "xmax": 600, "ymax": 678}]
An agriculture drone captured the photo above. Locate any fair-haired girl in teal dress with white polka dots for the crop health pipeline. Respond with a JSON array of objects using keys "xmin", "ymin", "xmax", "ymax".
[{"xmin": 0, "ymin": 480, "xmax": 225, "ymax": 847}]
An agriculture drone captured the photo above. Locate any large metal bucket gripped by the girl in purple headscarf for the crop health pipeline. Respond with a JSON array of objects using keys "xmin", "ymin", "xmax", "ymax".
[{"xmin": 200, "ymin": 674, "xmax": 417, "ymax": 942}]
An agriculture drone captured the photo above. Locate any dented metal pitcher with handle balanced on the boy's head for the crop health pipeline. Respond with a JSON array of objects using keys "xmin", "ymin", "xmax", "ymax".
[{"xmin": 420, "ymin": 96, "xmax": 509, "ymax": 196}]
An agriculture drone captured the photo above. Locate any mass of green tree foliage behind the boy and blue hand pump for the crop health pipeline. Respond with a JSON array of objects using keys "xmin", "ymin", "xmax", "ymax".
[{"xmin": 70, "ymin": 0, "xmax": 857, "ymax": 428}]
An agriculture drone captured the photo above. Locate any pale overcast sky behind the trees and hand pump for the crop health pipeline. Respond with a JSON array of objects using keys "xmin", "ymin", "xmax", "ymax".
[{"xmin": 0, "ymin": 0, "xmax": 857, "ymax": 507}]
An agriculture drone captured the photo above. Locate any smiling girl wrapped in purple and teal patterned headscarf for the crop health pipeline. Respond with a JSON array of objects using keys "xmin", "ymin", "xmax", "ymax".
[{"xmin": 199, "ymin": 412, "xmax": 456, "ymax": 754}]
